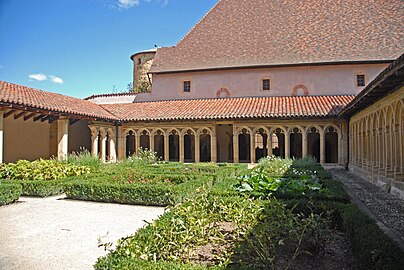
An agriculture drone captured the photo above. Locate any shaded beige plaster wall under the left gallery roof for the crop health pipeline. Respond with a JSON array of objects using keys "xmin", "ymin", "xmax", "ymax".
[{"xmin": 4, "ymin": 116, "xmax": 51, "ymax": 163}]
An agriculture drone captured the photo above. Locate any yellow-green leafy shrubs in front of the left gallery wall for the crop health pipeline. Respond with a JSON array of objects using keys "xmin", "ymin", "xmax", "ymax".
[{"xmin": 0, "ymin": 159, "xmax": 90, "ymax": 180}]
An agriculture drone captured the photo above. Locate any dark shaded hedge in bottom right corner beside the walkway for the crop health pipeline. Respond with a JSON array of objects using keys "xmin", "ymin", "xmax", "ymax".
[{"xmin": 342, "ymin": 204, "xmax": 404, "ymax": 270}]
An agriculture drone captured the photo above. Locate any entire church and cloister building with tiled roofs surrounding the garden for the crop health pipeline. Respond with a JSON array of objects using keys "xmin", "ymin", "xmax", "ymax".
[{"xmin": 0, "ymin": 0, "xmax": 404, "ymax": 198}]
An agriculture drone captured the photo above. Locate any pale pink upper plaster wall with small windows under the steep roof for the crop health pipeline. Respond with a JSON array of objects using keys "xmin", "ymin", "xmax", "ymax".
[{"xmin": 150, "ymin": 64, "xmax": 387, "ymax": 101}]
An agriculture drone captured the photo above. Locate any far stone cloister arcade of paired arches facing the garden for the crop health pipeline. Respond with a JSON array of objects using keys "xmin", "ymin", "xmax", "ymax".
[{"xmin": 90, "ymin": 122, "xmax": 346, "ymax": 164}]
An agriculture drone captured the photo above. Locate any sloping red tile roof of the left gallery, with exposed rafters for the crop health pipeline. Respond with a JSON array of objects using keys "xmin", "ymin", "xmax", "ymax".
[{"xmin": 0, "ymin": 81, "xmax": 117, "ymax": 120}]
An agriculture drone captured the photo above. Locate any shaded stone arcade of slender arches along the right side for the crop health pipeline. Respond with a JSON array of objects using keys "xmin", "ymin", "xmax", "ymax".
[{"xmin": 349, "ymin": 88, "xmax": 404, "ymax": 196}]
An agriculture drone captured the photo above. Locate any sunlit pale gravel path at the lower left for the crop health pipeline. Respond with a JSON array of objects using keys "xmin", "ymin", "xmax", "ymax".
[{"xmin": 0, "ymin": 196, "xmax": 164, "ymax": 270}]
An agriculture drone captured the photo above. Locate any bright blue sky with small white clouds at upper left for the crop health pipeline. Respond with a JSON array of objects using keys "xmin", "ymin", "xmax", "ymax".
[{"xmin": 0, "ymin": 0, "xmax": 217, "ymax": 98}]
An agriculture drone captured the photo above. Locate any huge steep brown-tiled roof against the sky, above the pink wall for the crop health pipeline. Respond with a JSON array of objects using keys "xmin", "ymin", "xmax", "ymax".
[{"xmin": 151, "ymin": 0, "xmax": 404, "ymax": 73}]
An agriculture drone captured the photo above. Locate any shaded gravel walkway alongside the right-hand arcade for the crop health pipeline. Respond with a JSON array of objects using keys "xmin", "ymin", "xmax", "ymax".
[{"xmin": 330, "ymin": 169, "xmax": 404, "ymax": 249}]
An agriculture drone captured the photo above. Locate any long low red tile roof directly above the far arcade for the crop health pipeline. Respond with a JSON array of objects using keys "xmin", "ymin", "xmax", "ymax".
[{"xmin": 101, "ymin": 96, "xmax": 354, "ymax": 121}]
